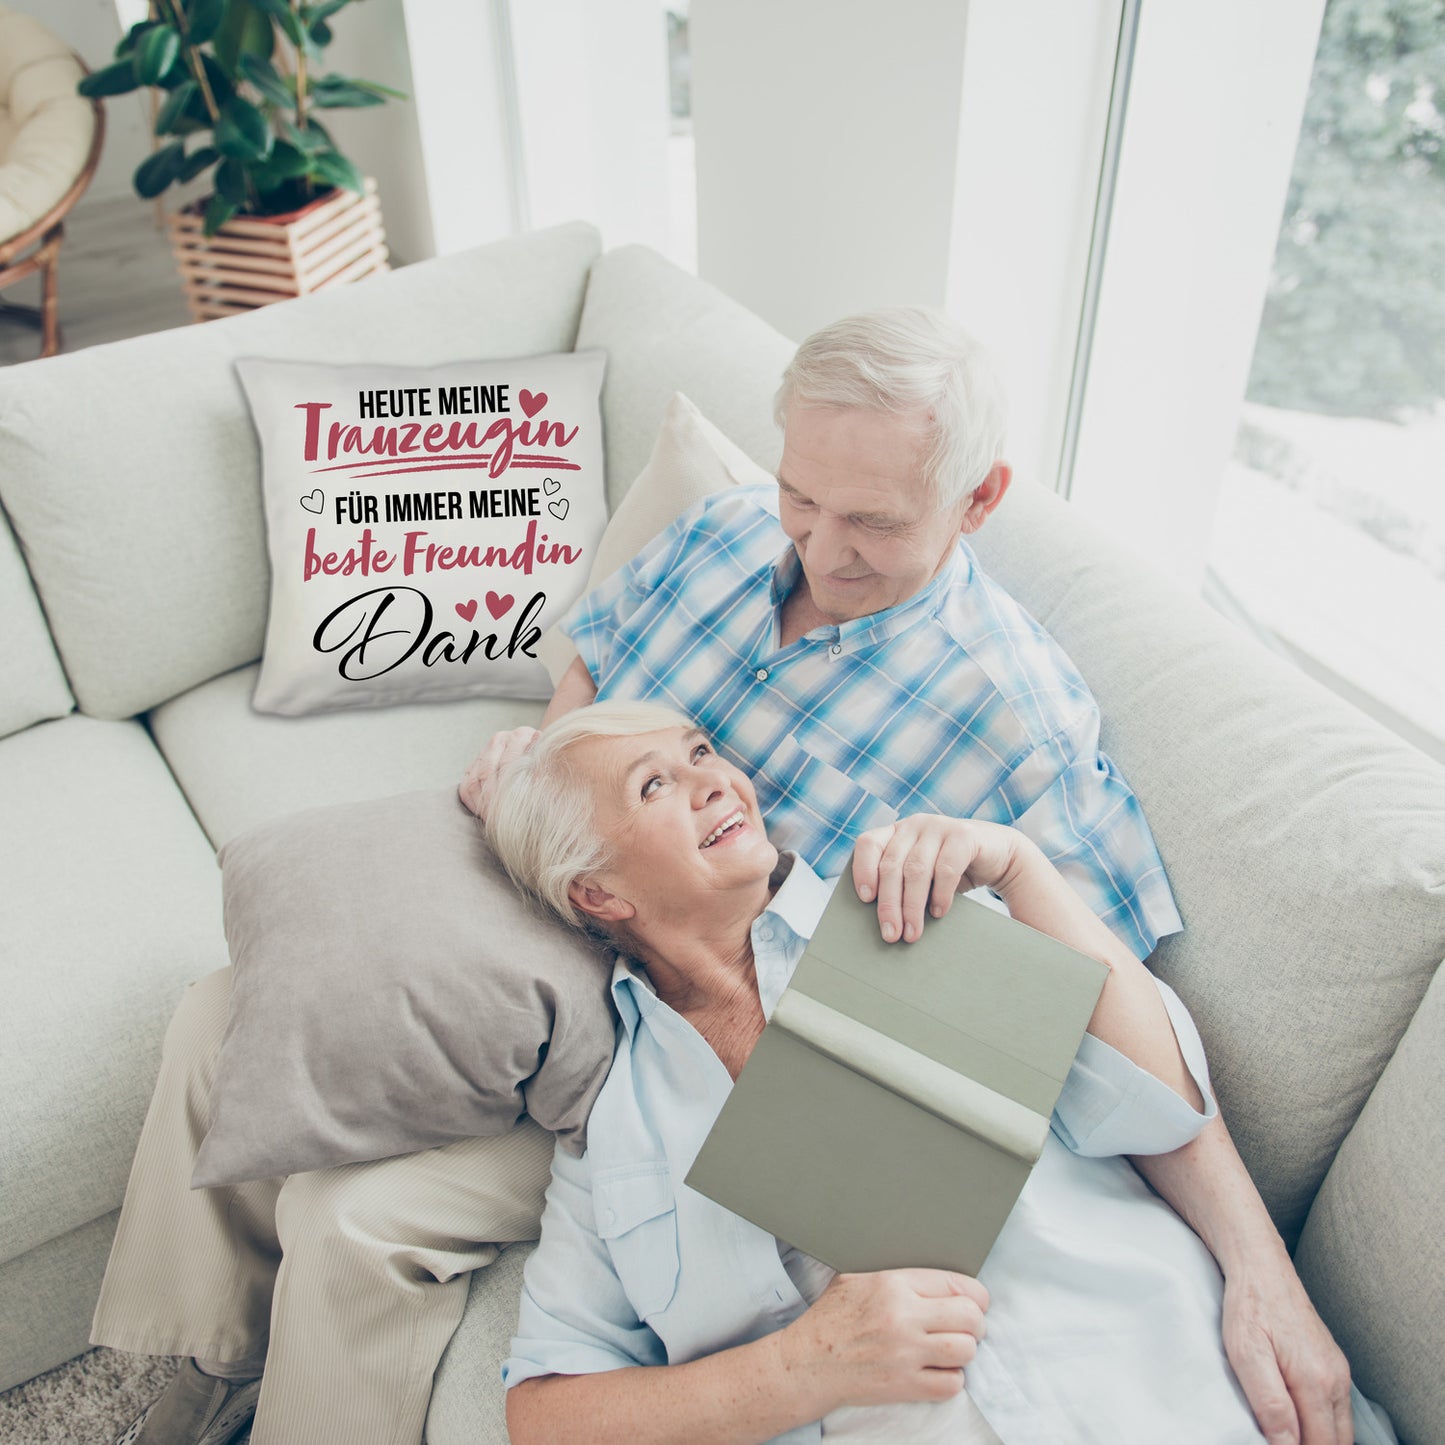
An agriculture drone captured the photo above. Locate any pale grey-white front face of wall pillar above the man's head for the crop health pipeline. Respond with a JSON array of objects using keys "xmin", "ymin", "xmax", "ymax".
[{"xmin": 691, "ymin": 0, "xmax": 968, "ymax": 338}]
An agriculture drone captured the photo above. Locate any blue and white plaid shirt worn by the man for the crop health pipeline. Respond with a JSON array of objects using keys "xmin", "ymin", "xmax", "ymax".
[{"xmin": 562, "ymin": 487, "xmax": 1182, "ymax": 958}]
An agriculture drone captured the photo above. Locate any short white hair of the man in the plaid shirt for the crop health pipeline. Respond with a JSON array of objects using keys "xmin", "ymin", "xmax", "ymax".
[{"xmin": 773, "ymin": 306, "xmax": 1006, "ymax": 507}]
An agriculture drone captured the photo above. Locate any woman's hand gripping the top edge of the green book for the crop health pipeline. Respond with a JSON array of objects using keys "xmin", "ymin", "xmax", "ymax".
[{"xmin": 853, "ymin": 814, "xmax": 1033, "ymax": 944}]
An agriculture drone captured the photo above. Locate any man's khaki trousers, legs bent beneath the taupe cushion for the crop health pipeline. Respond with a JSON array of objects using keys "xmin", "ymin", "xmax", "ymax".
[{"xmin": 91, "ymin": 968, "xmax": 552, "ymax": 1445}]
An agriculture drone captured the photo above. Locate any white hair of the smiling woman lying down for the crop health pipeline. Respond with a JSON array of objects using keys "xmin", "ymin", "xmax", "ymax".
[{"xmin": 487, "ymin": 702, "xmax": 694, "ymax": 942}]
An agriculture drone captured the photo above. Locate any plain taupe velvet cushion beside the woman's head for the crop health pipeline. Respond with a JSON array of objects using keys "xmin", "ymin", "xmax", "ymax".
[{"xmin": 192, "ymin": 790, "xmax": 616, "ymax": 1188}]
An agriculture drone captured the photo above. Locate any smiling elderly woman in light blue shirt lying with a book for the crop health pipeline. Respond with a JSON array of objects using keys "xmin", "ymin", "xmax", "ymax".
[{"xmin": 487, "ymin": 704, "xmax": 1312, "ymax": 1445}]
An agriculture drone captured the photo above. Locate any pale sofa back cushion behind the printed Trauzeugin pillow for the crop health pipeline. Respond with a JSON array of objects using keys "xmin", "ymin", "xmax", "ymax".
[{"xmin": 0, "ymin": 225, "xmax": 597, "ymax": 718}]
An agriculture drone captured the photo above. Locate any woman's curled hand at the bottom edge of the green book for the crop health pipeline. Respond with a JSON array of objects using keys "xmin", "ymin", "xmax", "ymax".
[{"xmin": 779, "ymin": 1269, "xmax": 988, "ymax": 1413}]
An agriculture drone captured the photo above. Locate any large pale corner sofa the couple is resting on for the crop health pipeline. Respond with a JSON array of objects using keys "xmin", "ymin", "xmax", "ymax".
[{"xmin": 0, "ymin": 225, "xmax": 1445, "ymax": 1445}]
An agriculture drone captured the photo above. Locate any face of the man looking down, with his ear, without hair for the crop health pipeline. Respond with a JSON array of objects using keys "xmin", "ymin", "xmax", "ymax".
[{"xmin": 777, "ymin": 407, "xmax": 981, "ymax": 623}]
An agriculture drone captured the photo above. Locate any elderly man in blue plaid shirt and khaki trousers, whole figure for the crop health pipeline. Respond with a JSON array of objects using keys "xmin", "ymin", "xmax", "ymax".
[{"xmin": 92, "ymin": 311, "xmax": 1350, "ymax": 1445}]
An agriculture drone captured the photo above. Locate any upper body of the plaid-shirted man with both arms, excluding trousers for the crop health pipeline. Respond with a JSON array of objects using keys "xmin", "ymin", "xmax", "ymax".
[{"xmin": 462, "ymin": 311, "xmax": 1351, "ymax": 1445}]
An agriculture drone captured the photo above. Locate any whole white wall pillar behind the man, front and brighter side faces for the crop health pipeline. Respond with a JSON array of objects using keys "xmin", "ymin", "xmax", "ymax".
[{"xmin": 692, "ymin": 0, "xmax": 1121, "ymax": 487}]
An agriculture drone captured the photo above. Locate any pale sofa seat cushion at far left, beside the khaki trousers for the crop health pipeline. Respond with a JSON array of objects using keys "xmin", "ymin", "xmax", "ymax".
[{"xmin": 0, "ymin": 715, "xmax": 225, "ymax": 1261}]
